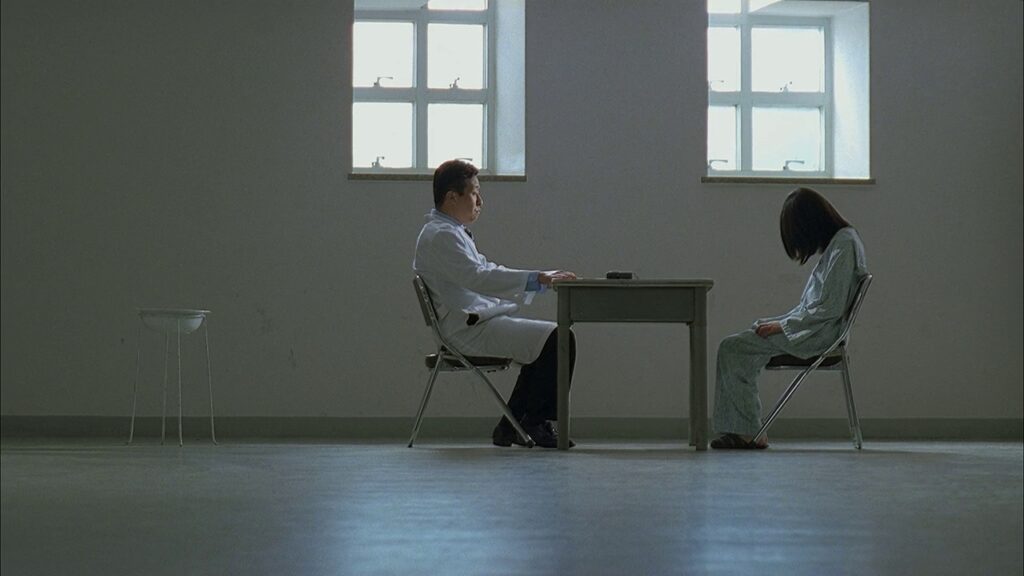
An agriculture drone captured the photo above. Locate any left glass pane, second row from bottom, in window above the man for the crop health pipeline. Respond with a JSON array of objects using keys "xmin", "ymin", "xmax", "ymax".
[{"xmin": 352, "ymin": 22, "xmax": 414, "ymax": 88}]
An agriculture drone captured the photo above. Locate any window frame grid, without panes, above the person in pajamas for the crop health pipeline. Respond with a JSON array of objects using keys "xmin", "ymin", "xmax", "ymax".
[{"xmin": 706, "ymin": 7, "xmax": 835, "ymax": 179}]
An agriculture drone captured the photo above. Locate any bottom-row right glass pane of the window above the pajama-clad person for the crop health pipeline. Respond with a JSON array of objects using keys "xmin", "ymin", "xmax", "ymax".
[{"xmin": 751, "ymin": 108, "xmax": 822, "ymax": 171}]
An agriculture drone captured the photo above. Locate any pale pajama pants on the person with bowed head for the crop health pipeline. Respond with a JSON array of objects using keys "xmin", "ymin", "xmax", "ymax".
[{"xmin": 713, "ymin": 330, "xmax": 786, "ymax": 436}]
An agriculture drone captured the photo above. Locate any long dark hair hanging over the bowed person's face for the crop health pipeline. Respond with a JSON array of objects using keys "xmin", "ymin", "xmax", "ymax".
[{"xmin": 778, "ymin": 188, "xmax": 850, "ymax": 263}]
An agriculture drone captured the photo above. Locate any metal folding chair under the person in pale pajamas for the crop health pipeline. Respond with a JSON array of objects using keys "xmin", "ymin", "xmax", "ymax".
[{"xmin": 754, "ymin": 274, "xmax": 873, "ymax": 450}]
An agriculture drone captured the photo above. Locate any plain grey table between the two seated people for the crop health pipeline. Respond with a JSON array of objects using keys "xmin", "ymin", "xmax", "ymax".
[{"xmin": 555, "ymin": 279, "xmax": 715, "ymax": 450}]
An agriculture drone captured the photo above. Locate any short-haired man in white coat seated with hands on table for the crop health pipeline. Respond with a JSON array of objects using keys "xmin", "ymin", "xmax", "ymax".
[{"xmin": 413, "ymin": 160, "xmax": 575, "ymax": 448}]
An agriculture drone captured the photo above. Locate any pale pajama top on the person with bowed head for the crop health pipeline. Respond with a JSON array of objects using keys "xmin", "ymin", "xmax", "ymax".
[{"xmin": 756, "ymin": 227, "xmax": 867, "ymax": 358}]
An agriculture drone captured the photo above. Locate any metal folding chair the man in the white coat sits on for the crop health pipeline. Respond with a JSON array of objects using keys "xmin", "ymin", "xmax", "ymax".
[{"xmin": 409, "ymin": 275, "xmax": 534, "ymax": 448}]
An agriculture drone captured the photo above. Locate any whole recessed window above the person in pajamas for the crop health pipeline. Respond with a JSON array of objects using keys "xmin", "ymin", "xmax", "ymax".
[{"xmin": 708, "ymin": 0, "xmax": 869, "ymax": 178}]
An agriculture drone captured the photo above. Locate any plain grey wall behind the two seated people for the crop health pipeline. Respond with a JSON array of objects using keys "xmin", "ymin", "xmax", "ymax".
[{"xmin": 2, "ymin": 0, "xmax": 1024, "ymax": 418}]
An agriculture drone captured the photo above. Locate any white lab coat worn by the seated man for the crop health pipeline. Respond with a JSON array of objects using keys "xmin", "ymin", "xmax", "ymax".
[{"xmin": 413, "ymin": 210, "xmax": 557, "ymax": 364}]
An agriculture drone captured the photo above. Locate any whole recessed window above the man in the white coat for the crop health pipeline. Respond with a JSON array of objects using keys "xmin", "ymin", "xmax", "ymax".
[{"xmin": 352, "ymin": 0, "xmax": 525, "ymax": 175}]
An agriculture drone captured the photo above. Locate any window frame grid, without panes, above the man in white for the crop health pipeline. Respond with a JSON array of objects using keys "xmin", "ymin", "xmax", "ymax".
[{"xmin": 350, "ymin": 0, "xmax": 498, "ymax": 175}]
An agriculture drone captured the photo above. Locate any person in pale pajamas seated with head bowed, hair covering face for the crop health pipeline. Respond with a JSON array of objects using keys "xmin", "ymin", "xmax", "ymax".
[{"xmin": 711, "ymin": 188, "xmax": 867, "ymax": 449}]
